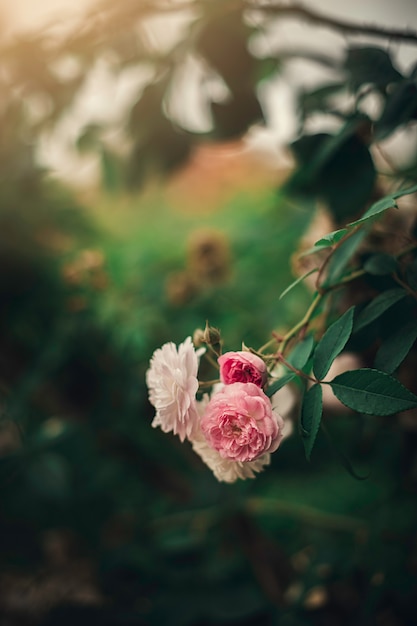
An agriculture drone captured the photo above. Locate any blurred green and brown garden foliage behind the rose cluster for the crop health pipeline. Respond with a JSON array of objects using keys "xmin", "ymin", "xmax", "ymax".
[{"xmin": 0, "ymin": 0, "xmax": 417, "ymax": 626}]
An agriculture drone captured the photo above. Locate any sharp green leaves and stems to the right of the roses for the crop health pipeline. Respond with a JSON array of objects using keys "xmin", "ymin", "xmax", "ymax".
[{"xmin": 272, "ymin": 186, "xmax": 417, "ymax": 459}]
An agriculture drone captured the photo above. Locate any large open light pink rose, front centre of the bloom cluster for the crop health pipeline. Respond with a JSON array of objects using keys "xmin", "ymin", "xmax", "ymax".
[{"xmin": 201, "ymin": 383, "xmax": 284, "ymax": 462}]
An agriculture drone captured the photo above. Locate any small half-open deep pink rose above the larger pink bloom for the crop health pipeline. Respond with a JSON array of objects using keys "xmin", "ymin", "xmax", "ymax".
[{"xmin": 218, "ymin": 352, "xmax": 268, "ymax": 387}]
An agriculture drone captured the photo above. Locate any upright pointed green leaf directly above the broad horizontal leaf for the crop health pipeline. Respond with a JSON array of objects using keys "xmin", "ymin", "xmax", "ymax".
[{"xmin": 313, "ymin": 307, "xmax": 355, "ymax": 380}]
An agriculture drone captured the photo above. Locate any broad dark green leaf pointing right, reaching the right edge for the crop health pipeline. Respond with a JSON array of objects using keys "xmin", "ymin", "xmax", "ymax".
[{"xmin": 330, "ymin": 368, "xmax": 417, "ymax": 415}]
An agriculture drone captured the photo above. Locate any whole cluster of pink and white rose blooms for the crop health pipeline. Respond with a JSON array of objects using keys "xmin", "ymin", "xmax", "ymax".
[{"xmin": 146, "ymin": 337, "xmax": 290, "ymax": 483}]
